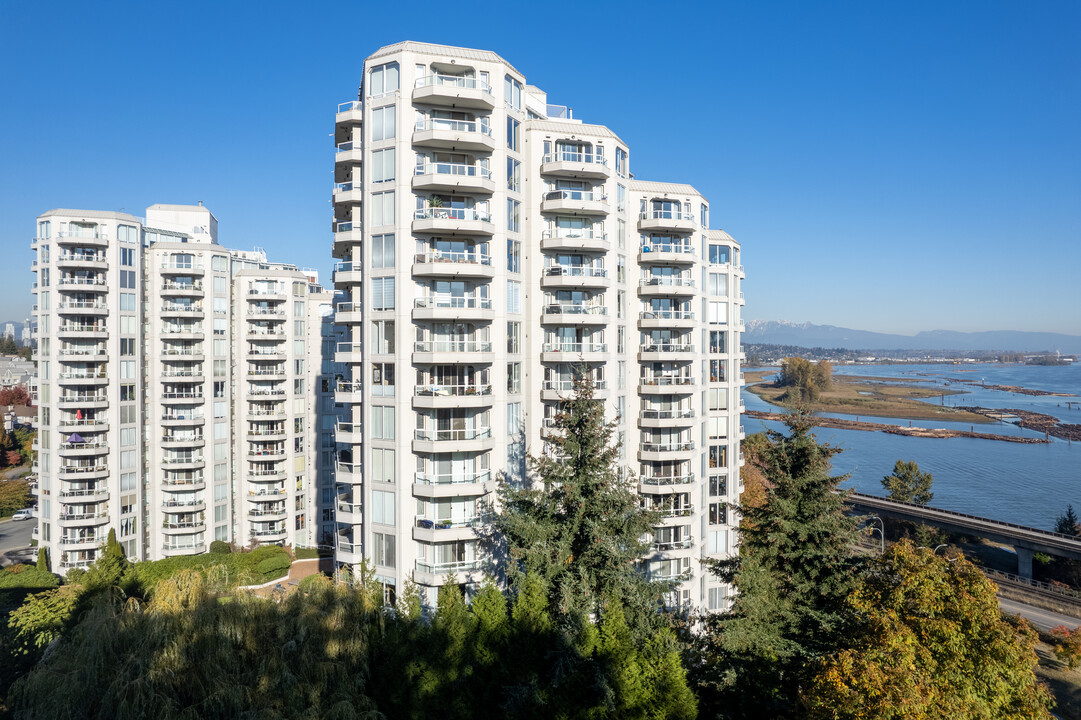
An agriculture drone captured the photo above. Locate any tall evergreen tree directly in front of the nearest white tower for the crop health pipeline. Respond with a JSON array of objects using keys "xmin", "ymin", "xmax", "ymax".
[{"xmin": 495, "ymin": 378, "xmax": 665, "ymax": 623}]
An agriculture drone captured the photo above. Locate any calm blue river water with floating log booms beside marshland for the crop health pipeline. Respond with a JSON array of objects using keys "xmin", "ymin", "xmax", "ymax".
[{"xmin": 743, "ymin": 364, "xmax": 1081, "ymax": 530}]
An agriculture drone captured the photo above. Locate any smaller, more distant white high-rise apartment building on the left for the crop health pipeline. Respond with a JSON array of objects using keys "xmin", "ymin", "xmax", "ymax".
[{"xmin": 32, "ymin": 204, "xmax": 335, "ymax": 572}]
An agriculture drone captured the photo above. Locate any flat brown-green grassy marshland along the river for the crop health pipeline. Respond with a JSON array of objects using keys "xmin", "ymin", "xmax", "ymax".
[{"xmin": 745, "ymin": 371, "xmax": 995, "ymax": 425}]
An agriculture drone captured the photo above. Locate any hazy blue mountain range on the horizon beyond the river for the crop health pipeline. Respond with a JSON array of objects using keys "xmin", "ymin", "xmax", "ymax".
[{"xmin": 743, "ymin": 320, "xmax": 1081, "ymax": 355}]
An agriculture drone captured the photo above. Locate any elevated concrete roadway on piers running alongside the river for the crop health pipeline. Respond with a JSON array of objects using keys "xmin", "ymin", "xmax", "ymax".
[{"xmin": 845, "ymin": 493, "xmax": 1081, "ymax": 578}]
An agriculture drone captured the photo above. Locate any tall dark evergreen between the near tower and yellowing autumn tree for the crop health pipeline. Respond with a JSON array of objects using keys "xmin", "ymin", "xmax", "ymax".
[{"xmin": 695, "ymin": 410, "xmax": 856, "ymax": 718}]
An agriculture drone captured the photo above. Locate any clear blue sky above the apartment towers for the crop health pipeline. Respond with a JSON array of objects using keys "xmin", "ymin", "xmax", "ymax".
[{"xmin": 0, "ymin": 0, "xmax": 1081, "ymax": 334}]
